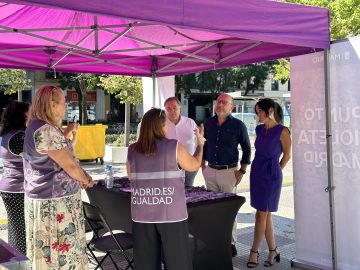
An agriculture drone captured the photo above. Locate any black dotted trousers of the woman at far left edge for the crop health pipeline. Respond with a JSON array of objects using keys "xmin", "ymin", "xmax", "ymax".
[{"xmin": 1, "ymin": 192, "xmax": 26, "ymax": 255}]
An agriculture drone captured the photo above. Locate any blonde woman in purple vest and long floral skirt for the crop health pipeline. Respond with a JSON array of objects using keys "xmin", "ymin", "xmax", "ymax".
[{"xmin": 23, "ymin": 86, "xmax": 94, "ymax": 270}]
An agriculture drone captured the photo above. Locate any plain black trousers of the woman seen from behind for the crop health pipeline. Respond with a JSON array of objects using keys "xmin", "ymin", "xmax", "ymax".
[{"xmin": 133, "ymin": 220, "xmax": 193, "ymax": 270}]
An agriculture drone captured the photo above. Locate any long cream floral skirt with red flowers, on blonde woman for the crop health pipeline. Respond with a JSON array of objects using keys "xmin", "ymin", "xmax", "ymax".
[{"xmin": 25, "ymin": 191, "xmax": 89, "ymax": 270}]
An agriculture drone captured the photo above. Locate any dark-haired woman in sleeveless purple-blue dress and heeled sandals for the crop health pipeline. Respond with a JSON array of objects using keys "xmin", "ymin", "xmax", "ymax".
[{"xmin": 247, "ymin": 98, "xmax": 291, "ymax": 268}]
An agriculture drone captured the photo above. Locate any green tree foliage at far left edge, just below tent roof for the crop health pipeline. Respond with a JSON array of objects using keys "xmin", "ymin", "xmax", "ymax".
[{"xmin": 0, "ymin": 68, "xmax": 31, "ymax": 95}]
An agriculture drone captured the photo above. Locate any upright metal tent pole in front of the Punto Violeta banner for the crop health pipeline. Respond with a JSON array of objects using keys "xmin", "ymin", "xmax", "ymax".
[{"xmin": 324, "ymin": 50, "xmax": 337, "ymax": 270}]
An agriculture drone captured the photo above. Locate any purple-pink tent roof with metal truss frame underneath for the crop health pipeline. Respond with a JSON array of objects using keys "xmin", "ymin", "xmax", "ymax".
[{"xmin": 0, "ymin": 0, "xmax": 330, "ymax": 76}]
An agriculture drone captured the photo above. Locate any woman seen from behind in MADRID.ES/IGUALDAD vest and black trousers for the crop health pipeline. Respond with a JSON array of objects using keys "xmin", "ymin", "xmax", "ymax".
[{"xmin": 126, "ymin": 108, "xmax": 205, "ymax": 270}]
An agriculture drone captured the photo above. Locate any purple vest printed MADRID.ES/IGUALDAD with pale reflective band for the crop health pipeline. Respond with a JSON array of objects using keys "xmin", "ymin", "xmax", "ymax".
[{"xmin": 128, "ymin": 139, "xmax": 187, "ymax": 223}]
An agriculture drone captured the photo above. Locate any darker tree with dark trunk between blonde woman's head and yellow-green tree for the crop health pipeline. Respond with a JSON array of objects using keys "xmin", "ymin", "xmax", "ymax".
[{"xmin": 59, "ymin": 73, "xmax": 99, "ymax": 124}]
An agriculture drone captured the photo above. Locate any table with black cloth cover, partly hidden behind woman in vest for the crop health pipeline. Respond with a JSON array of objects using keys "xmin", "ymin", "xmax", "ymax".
[{"xmin": 86, "ymin": 178, "xmax": 245, "ymax": 270}]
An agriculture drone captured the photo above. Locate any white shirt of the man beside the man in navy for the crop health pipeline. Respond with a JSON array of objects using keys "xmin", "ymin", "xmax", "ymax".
[{"xmin": 166, "ymin": 115, "xmax": 197, "ymax": 155}]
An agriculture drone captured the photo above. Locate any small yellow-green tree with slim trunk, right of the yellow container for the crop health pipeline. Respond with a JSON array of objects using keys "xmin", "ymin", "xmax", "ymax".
[{"xmin": 98, "ymin": 75, "xmax": 142, "ymax": 146}]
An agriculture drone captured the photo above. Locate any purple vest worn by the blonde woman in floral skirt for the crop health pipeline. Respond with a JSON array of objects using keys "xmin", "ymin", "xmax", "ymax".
[{"xmin": 23, "ymin": 120, "xmax": 79, "ymax": 199}]
